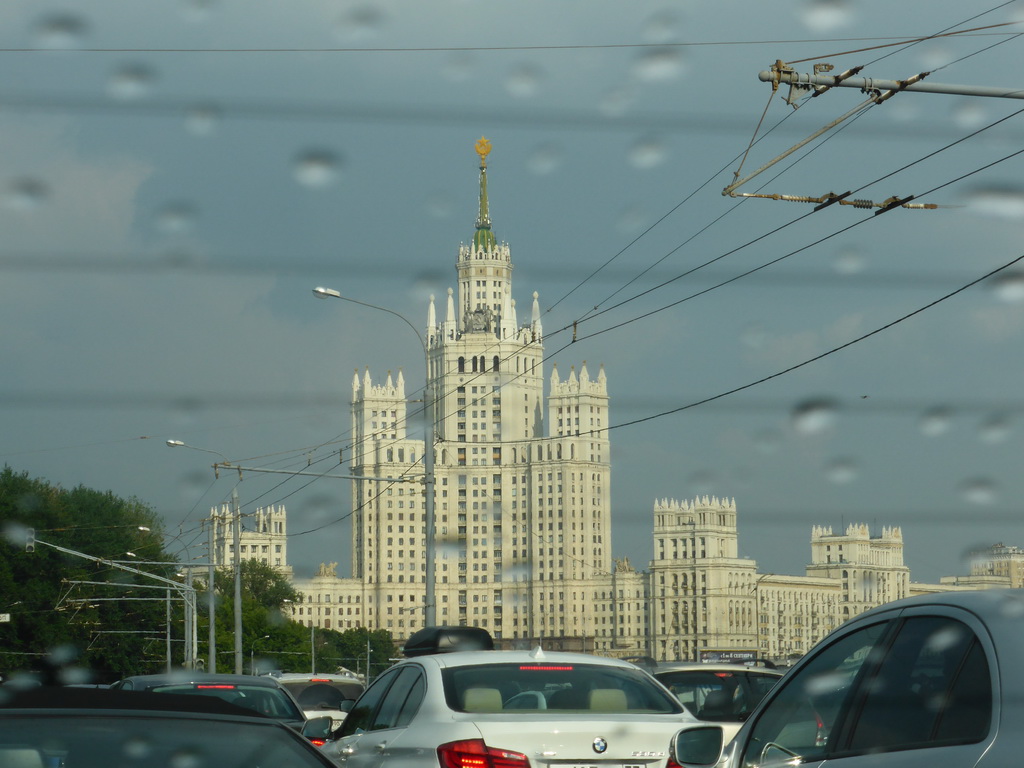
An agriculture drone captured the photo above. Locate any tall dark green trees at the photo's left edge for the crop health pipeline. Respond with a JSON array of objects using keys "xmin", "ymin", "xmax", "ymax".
[{"xmin": 0, "ymin": 467, "xmax": 174, "ymax": 681}]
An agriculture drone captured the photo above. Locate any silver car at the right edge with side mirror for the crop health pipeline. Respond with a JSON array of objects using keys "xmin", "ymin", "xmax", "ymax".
[{"xmin": 674, "ymin": 590, "xmax": 1024, "ymax": 768}]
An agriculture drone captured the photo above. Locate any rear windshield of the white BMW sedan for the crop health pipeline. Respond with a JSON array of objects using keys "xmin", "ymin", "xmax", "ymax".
[{"xmin": 441, "ymin": 662, "xmax": 683, "ymax": 715}]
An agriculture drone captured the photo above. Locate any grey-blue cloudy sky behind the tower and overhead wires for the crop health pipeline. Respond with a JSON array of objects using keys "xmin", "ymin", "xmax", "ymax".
[{"xmin": 0, "ymin": 0, "xmax": 1024, "ymax": 583}]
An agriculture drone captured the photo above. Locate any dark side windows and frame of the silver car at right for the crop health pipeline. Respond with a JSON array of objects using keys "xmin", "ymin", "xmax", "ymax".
[{"xmin": 733, "ymin": 610, "xmax": 992, "ymax": 768}]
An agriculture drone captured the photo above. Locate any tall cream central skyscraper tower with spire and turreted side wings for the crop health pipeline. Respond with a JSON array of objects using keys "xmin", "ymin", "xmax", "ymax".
[{"xmin": 349, "ymin": 138, "xmax": 612, "ymax": 647}]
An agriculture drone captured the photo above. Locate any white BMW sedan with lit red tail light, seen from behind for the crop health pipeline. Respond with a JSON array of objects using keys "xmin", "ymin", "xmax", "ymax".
[{"xmin": 323, "ymin": 628, "xmax": 699, "ymax": 768}]
